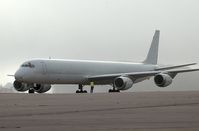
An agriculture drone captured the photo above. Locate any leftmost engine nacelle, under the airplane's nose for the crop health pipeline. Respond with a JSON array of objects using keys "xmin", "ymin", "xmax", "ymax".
[{"xmin": 13, "ymin": 81, "xmax": 30, "ymax": 92}]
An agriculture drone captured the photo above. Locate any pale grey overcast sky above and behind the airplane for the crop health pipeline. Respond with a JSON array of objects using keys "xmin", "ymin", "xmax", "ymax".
[{"xmin": 0, "ymin": 0, "xmax": 199, "ymax": 92}]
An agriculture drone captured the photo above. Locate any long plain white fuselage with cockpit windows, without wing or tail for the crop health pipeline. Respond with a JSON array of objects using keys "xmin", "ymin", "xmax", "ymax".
[{"xmin": 15, "ymin": 59, "xmax": 156, "ymax": 84}]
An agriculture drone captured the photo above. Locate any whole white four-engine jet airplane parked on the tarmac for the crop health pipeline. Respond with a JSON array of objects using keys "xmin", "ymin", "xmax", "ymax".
[{"xmin": 13, "ymin": 30, "xmax": 199, "ymax": 93}]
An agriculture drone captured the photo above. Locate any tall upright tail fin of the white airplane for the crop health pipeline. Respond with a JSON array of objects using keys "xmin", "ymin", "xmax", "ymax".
[{"xmin": 143, "ymin": 30, "xmax": 160, "ymax": 65}]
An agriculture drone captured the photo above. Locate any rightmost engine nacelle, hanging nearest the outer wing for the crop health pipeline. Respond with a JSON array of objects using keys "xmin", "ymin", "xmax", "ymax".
[{"xmin": 154, "ymin": 74, "xmax": 173, "ymax": 87}]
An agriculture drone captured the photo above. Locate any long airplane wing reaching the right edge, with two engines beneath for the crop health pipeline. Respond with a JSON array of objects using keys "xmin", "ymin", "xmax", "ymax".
[{"xmin": 87, "ymin": 69, "xmax": 199, "ymax": 81}]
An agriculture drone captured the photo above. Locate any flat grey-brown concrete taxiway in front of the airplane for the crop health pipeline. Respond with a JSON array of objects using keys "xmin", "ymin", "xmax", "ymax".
[{"xmin": 0, "ymin": 92, "xmax": 199, "ymax": 131}]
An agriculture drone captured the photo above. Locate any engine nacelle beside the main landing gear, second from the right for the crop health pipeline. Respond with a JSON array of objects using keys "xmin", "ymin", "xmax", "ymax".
[{"xmin": 114, "ymin": 76, "xmax": 133, "ymax": 90}]
